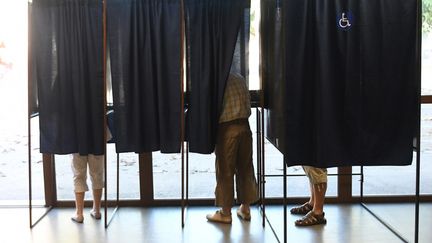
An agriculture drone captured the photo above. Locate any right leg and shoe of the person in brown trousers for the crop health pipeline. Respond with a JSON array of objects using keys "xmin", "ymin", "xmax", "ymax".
[{"xmin": 236, "ymin": 121, "xmax": 259, "ymax": 220}]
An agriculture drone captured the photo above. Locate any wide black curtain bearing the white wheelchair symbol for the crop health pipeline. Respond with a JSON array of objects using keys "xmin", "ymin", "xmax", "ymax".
[{"xmin": 264, "ymin": 0, "xmax": 420, "ymax": 167}]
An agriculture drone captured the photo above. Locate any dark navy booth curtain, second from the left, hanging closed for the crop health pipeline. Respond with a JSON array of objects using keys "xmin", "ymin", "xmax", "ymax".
[{"xmin": 107, "ymin": 0, "xmax": 181, "ymax": 153}]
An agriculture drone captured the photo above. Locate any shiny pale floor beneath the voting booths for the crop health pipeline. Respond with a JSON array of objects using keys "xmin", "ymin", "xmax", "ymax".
[{"xmin": 0, "ymin": 204, "xmax": 432, "ymax": 243}]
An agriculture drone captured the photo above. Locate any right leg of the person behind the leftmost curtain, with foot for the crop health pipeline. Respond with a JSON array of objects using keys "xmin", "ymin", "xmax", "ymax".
[{"xmin": 89, "ymin": 155, "xmax": 104, "ymax": 219}]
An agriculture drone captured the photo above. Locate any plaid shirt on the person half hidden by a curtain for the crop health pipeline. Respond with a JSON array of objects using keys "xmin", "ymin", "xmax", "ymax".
[{"xmin": 219, "ymin": 73, "xmax": 251, "ymax": 123}]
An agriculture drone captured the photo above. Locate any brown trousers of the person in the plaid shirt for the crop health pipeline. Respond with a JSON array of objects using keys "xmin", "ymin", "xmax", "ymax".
[{"xmin": 215, "ymin": 119, "xmax": 258, "ymax": 207}]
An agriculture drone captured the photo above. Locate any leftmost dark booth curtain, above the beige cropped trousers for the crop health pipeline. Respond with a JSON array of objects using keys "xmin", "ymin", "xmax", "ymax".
[{"xmin": 30, "ymin": 0, "xmax": 105, "ymax": 155}]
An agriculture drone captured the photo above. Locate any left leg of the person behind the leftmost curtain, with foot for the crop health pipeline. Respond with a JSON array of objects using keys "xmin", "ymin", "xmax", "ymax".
[{"xmin": 72, "ymin": 154, "xmax": 88, "ymax": 223}]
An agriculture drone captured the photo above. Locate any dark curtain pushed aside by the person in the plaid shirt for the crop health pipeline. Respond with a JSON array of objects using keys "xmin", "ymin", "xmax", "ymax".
[{"xmin": 185, "ymin": 0, "xmax": 250, "ymax": 154}]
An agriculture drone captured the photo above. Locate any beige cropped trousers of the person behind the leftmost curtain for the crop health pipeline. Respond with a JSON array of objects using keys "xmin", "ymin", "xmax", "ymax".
[{"xmin": 72, "ymin": 154, "xmax": 104, "ymax": 192}]
